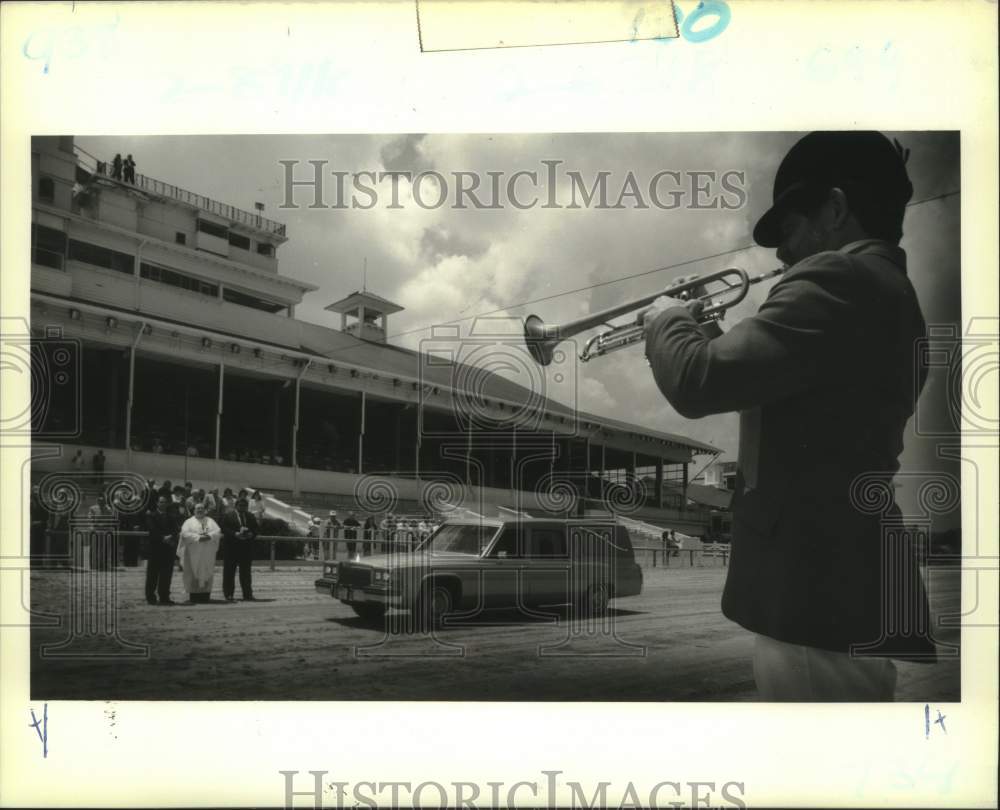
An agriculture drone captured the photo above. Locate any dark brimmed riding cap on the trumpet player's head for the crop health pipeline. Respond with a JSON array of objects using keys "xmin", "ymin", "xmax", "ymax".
[{"xmin": 753, "ymin": 132, "xmax": 913, "ymax": 247}]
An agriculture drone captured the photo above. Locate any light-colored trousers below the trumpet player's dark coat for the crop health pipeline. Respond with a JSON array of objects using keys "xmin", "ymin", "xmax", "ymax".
[{"xmin": 753, "ymin": 635, "xmax": 896, "ymax": 703}]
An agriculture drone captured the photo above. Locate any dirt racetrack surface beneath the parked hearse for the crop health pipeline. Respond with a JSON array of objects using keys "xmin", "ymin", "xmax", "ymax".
[{"xmin": 25, "ymin": 563, "xmax": 960, "ymax": 702}]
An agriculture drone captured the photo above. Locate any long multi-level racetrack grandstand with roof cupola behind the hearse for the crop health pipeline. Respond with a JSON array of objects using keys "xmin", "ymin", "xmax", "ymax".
[{"xmin": 31, "ymin": 137, "xmax": 717, "ymax": 533}]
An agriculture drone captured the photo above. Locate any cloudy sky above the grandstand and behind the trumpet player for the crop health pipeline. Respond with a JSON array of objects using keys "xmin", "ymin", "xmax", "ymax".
[{"xmin": 77, "ymin": 133, "xmax": 961, "ymax": 474}]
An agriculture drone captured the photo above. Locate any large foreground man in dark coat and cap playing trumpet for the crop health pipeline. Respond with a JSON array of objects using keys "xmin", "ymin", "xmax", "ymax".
[{"xmin": 642, "ymin": 132, "xmax": 935, "ymax": 701}]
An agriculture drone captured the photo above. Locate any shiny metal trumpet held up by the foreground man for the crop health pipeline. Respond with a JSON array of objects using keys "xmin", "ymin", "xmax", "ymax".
[{"xmin": 524, "ymin": 266, "xmax": 787, "ymax": 366}]
